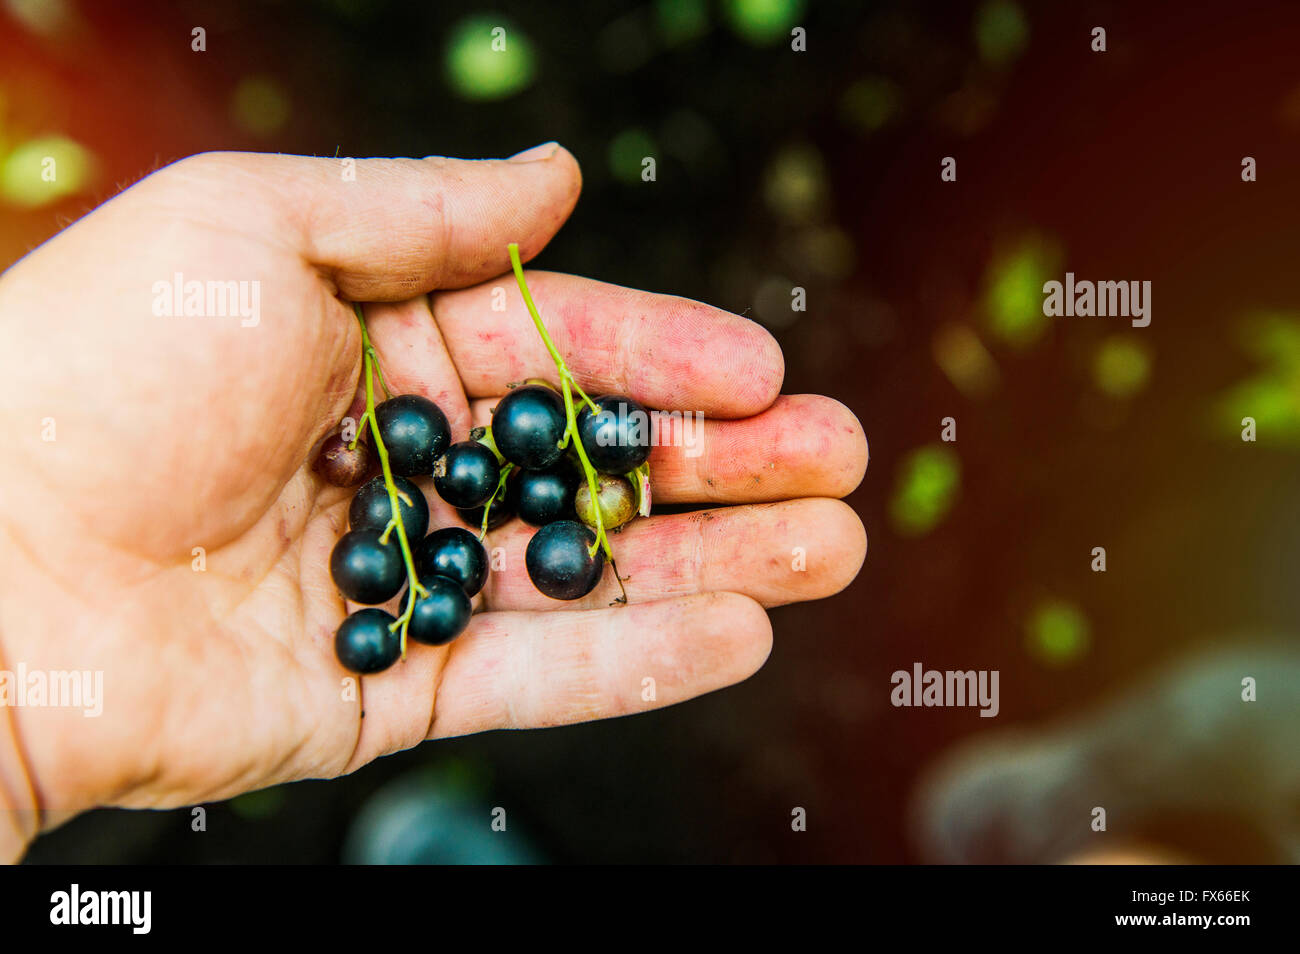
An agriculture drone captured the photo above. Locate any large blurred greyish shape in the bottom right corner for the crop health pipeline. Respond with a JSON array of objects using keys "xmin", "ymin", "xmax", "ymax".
[{"xmin": 913, "ymin": 649, "xmax": 1300, "ymax": 864}]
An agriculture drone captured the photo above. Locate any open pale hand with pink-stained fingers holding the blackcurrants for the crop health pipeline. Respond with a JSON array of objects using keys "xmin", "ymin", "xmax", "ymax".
[{"xmin": 0, "ymin": 144, "xmax": 867, "ymax": 860}]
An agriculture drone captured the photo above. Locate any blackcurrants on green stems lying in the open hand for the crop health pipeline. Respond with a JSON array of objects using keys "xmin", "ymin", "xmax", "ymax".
[{"xmin": 315, "ymin": 244, "xmax": 650, "ymax": 673}]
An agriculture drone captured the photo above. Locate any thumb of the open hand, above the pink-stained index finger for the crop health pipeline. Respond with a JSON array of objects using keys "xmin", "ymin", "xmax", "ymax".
[{"xmin": 193, "ymin": 143, "xmax": 582, "ymax": 302}]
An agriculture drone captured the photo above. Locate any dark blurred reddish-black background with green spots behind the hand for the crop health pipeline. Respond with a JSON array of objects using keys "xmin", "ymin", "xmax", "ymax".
[{"xmin": 0, "ymin": 0, "xmax": 1300, "ymax": 862}]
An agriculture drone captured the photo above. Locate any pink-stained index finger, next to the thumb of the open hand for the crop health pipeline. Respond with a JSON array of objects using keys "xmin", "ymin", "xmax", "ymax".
[{"xmin": 432, "ymin": 272, "xmax": 785, "ymax": 417}]
